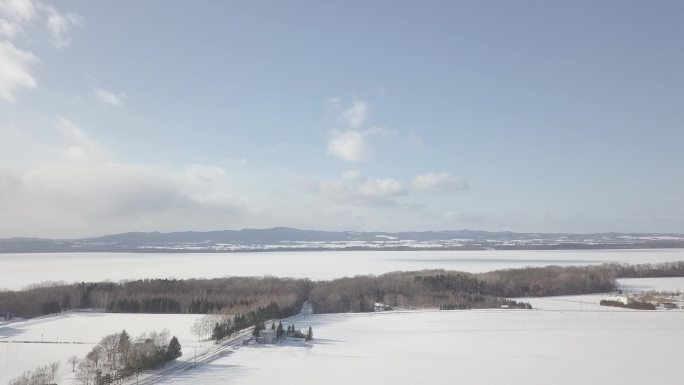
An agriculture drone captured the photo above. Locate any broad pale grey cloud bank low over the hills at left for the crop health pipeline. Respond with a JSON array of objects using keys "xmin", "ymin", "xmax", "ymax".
[{"xmin": 0, "ymin": 152, "xmax": 254, "ymax": 237}]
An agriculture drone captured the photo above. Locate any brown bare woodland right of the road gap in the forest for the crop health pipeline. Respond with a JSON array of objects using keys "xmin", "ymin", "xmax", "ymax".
[{"xmin": 309, "ymin": 266, "xmax": 615, "ymax": 313}]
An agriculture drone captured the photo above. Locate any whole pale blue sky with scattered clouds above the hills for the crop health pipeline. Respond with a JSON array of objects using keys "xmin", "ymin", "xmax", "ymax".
[{"xmin": 0, "ymin": 0, "xmax": 684, "ymax": 238}]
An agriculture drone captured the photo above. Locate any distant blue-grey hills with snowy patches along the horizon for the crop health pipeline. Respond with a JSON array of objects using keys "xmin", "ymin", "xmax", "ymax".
[{"xmin": 0, "ymin": 227, "xmax": 684, "ymax": 253}]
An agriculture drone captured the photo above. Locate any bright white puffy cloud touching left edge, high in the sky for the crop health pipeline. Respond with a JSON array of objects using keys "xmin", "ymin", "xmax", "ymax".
[{"xmin": 0, "ymin": 40, "xmax": 38, "ymax": 101}]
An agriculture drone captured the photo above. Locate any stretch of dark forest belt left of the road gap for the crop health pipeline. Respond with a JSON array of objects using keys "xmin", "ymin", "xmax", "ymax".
[{"xmin": 0, "ymin": 277, "xmax": 311, "ymax": 318}]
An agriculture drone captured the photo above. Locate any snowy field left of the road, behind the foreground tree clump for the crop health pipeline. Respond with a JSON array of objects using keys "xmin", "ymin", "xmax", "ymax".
[{"xmin": 0, "ymin": 313, "xmax": 206, "ymax": 385}]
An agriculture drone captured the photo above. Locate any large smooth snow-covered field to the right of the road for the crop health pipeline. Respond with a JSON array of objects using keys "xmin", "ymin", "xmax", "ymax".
[{"xmin": 152, "ymin": 310, "xmax": 684, "ymax": 385}]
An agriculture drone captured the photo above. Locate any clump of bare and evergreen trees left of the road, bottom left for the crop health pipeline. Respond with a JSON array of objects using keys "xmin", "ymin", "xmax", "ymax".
[{"xmin": 75, "ymin": 330, "xmax": 183, "ymax": 385}]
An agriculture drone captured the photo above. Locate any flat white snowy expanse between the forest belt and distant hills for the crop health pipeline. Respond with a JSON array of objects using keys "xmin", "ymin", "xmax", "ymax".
[{"xmin": 0, "ymin": 249, "xmax": 684, "ymax": 289}]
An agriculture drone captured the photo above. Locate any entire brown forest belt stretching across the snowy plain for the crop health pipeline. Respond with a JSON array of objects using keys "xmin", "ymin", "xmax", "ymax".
[{"xmin": 0, "ymin": 262, "xmax": 684, "ymax": 318}]
